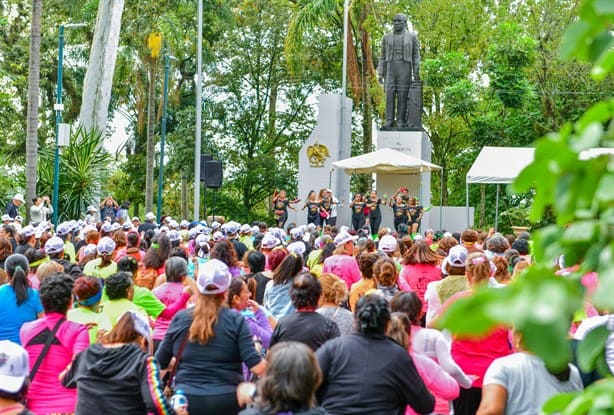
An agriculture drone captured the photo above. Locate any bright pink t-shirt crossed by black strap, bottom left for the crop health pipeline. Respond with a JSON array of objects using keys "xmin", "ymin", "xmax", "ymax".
[{"xmin": 19, "ymin": 313, "xmax": 90, "ymax": 415}]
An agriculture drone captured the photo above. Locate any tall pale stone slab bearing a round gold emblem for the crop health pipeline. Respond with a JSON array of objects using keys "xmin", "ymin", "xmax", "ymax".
[{"xmin": 286, "ymin": 94, "xmax": 352, "ymax": 226}]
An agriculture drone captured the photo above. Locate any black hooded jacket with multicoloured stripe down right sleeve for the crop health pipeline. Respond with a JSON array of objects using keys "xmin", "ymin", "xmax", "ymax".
[{"xmin": 63, "ymin": 344, "xmax": 175, "ymax": 415}]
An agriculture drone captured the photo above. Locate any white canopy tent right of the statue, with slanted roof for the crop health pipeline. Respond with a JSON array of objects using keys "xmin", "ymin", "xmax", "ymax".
[{"xmin": 465, "ymin": 146, "xmax": 535, "ymax": 230}]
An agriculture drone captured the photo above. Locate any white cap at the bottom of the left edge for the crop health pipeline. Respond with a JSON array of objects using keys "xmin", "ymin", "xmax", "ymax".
[{"xmin": 0, "ymin": 340, "xmax": 30, "ymax": 393}]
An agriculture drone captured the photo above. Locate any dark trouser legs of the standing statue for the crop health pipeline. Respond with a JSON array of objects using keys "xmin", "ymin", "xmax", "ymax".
[{"xmin": 385, "ymin": 61, "xmax": 411, "ymax": 127}]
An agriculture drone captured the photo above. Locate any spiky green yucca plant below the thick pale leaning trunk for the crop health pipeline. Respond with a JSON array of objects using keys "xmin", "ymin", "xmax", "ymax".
[{"xmin": 38, "ymin": 127, "xmax": 112, "ymax": 222}]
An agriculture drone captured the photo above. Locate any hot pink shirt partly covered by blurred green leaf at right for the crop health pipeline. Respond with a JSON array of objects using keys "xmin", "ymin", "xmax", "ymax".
[{"xmin": 443, "ymin": 291, "xmax": 513, "ymax": 388}]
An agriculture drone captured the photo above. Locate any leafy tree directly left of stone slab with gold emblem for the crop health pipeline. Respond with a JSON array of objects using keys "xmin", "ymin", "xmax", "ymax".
[{"xmin": 204, "ymin": 0, "xmax": 315, "ymax": 220}]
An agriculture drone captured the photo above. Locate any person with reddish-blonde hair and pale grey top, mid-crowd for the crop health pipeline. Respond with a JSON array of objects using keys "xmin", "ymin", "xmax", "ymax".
[{"xmin": 316, "ymin": 273, "xmax": 354, "ymax": 336}]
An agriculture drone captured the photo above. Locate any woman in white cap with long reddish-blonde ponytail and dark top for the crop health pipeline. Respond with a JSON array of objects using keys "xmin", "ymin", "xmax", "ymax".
[{"xmin": 156, "ymin": 259, "xmax": 266, "ymax": 415}]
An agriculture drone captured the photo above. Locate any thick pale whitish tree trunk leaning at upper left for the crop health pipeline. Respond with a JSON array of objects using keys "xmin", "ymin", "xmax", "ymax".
[{"xmin": 79, "ymin": 0, "xmax": 124, "ymax": 131}]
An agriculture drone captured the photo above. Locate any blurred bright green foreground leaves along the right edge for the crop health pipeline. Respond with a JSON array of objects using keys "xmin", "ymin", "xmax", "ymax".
[{"xmin": 442, "ymin": 0, "xmax": 614, "ymax": 415}]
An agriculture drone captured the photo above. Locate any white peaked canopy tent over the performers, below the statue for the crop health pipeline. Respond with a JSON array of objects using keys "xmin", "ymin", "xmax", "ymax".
[{"xmin": 332, "ymin": 148, "xmax": 443, "ymax": 225}]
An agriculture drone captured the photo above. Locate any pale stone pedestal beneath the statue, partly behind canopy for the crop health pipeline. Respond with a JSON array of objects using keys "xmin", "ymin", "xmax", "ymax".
[{"xmin": 376, "ymin": 129, "xmax": 431, "ymax": 231}]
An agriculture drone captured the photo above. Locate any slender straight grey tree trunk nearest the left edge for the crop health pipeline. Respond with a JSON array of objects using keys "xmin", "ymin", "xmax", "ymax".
[{"xmin": 26, "ymin": 0, "xmax": 43, "ymax": 223}]
